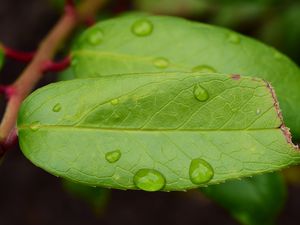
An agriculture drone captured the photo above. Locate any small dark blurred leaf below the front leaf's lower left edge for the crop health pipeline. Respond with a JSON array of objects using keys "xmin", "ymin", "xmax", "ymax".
[{"xmin": 62, "ymin": 179, "xmax": 110, "ymax": 214}]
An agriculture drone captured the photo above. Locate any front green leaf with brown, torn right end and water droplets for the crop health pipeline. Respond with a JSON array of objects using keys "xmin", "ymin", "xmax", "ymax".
[{"xmin": 18, "ymin": 72, "xmax": 300, "ymax": 191}]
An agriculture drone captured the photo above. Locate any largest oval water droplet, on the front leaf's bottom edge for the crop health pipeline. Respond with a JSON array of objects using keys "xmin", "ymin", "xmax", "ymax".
[{"xmin": 133, "ymin": 169, "xmax": 166, "ymax": 191}]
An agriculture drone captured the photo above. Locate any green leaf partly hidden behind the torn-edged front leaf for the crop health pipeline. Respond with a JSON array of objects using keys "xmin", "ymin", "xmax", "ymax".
[{"xmin": 72, "ymin": 15, "xmax": 300, "ymax": 138}]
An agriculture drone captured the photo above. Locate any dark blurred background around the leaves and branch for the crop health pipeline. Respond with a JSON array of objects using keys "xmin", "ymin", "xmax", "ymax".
[{"xmin": 0, "ymin": 0, "xmax": 300, "ymax": 225}]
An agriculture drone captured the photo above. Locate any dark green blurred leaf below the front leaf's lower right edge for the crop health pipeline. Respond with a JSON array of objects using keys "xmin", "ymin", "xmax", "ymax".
[{"xmin": 201, "ymin": 173, "xmax": 286, "ymax": 225}]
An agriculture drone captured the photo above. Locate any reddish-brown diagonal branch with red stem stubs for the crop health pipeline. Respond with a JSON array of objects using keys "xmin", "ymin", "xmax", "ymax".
[{"xmin": 0, "ymin": 0, "xmax": 106, "ymax": 149}]
